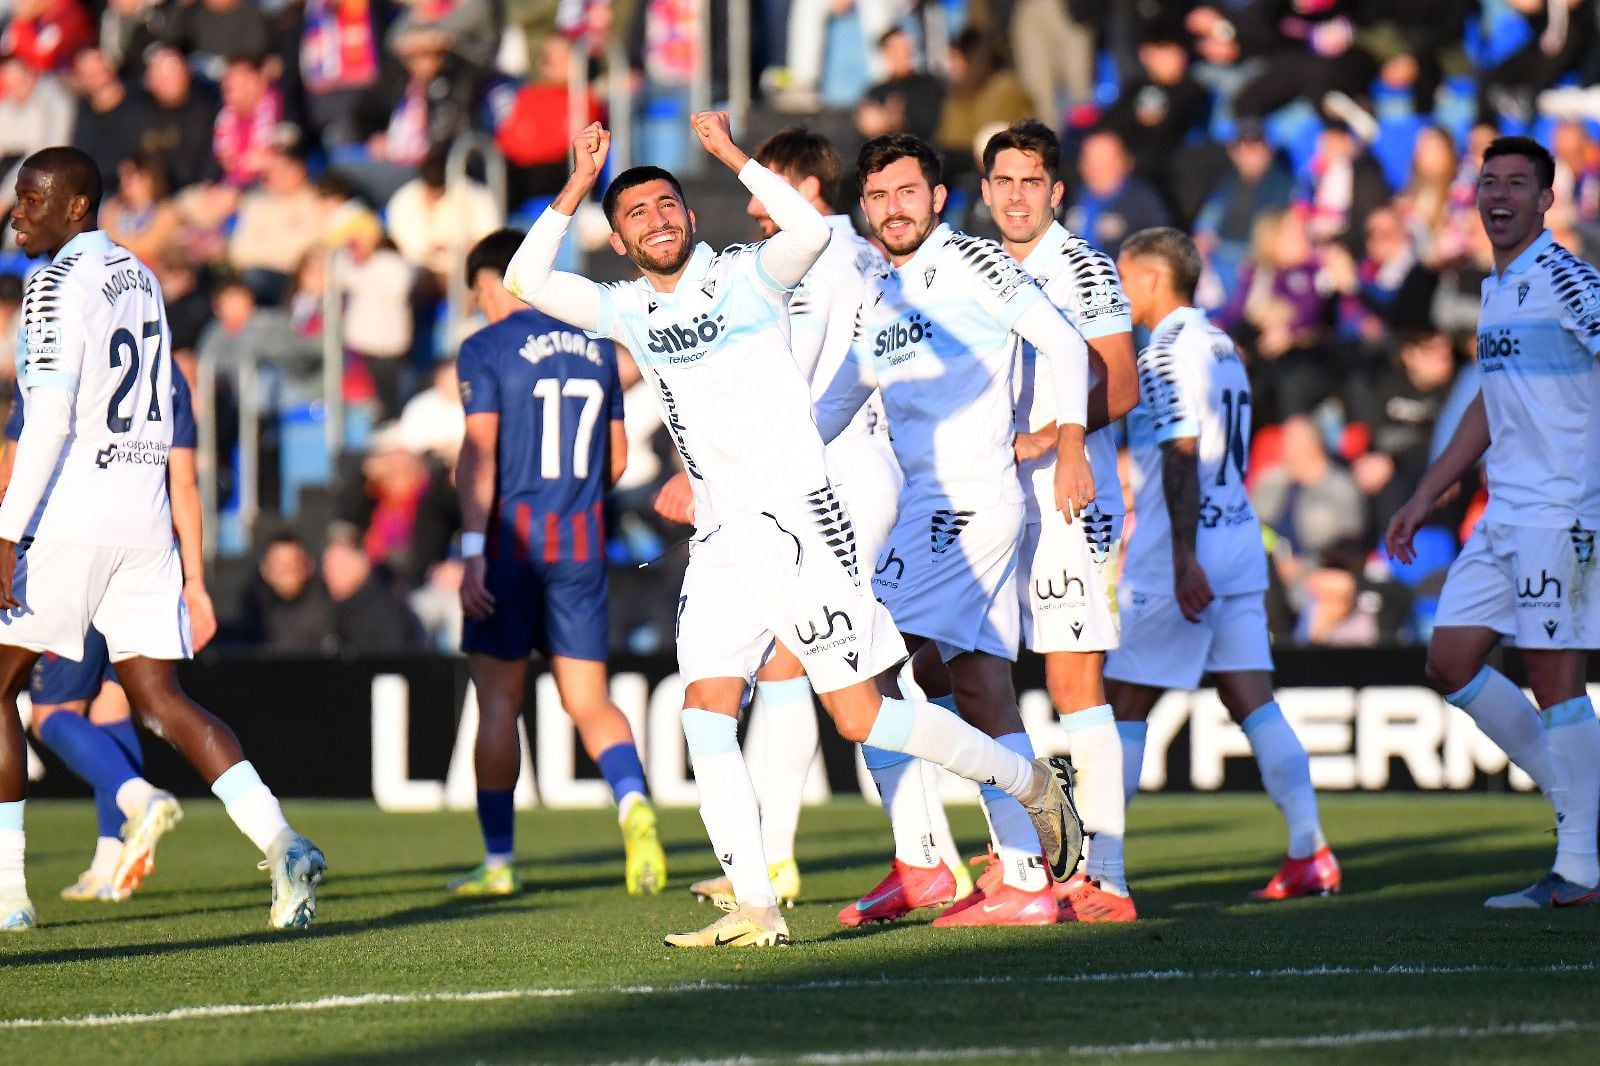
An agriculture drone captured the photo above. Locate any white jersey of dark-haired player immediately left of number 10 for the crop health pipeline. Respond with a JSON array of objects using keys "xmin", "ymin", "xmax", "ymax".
[{"xmin": 1016, "ymin": 222, "xmax": 1133, "ymax": 522}]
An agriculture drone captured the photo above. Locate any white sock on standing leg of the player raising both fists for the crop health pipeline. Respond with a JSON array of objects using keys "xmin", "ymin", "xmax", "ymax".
[{"xmin": 683, "ymin": 707, "xmax": 778, "ymax": 909}]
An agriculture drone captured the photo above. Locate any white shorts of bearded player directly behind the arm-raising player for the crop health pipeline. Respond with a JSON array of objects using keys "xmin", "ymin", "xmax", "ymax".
[{"xmin": 872, "ymin": 503, "xmax": 1022, "ymax": 663}]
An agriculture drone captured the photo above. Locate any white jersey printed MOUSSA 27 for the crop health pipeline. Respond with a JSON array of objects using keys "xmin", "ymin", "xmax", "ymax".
[{"xmin": 19, "ymin": 230, "xmax": 173, "ymax": 549}]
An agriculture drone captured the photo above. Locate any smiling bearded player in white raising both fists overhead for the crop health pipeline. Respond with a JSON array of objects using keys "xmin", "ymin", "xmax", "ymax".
[{"xmin": 507, "ymin": 112, "xmax": 1090, "ymax": 948}]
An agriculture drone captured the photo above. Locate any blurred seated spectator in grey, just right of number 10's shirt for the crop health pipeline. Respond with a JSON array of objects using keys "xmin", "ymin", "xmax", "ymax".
[{"xmin": 1250, "ymin": 415, "xmax": 1365, "ymax": 595}]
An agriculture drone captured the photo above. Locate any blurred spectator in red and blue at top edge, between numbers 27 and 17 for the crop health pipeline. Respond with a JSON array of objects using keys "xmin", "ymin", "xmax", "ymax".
[{"xmin": 299, "ymin": 0, "xmax": 389, "ymax": 146}]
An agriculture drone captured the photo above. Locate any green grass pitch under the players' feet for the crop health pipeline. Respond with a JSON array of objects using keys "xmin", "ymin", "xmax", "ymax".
[{"xmin": 0, "ymin": 794, "xmax": 1600, "ymax": 1064}]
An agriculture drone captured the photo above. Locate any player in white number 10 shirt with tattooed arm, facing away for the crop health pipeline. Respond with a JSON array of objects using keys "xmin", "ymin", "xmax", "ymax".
[{"xmin": 1091, "ymin": 227, "xmax": 1339, "ymax": 900}]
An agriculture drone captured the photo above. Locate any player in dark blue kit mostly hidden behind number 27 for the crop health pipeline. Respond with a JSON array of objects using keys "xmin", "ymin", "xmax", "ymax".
[{"xmin": 0, "ymin": 364, "xmax": 216, "ymax": 903}]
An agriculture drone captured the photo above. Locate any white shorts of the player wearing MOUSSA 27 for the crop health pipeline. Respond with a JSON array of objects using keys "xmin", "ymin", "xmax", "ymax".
[{"xmin": 0, "ymin": 541, "xmax": 194, "ymax": 663}]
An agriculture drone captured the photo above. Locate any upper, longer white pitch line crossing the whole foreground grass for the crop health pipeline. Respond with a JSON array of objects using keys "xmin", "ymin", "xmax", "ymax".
[{"xmin": 0, "ymin": 962, "xmax": 1600, "ymax": 1024}]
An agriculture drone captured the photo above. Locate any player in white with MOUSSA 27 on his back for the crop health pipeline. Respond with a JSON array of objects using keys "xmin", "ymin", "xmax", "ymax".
[{"xmin": 0, "ymin": 147, "xmax": 326, "ymax": 930}]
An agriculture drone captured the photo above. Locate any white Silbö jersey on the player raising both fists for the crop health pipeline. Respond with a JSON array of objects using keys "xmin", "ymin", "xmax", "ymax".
[{"xmin": 594, "ymin": 236, "xmax": 827, "ymax": 515}]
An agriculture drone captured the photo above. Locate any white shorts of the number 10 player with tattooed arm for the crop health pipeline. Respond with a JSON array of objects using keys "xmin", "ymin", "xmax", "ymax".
[{"xmin": 1106, "ymin": 589, "xmax": 1272, "ymax": 688}]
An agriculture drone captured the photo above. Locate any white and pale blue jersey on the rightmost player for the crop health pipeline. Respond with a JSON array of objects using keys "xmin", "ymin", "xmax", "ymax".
[{"xmin": 1478, "ymin": 230, "xmax": 1600, "ymax": 528}]
